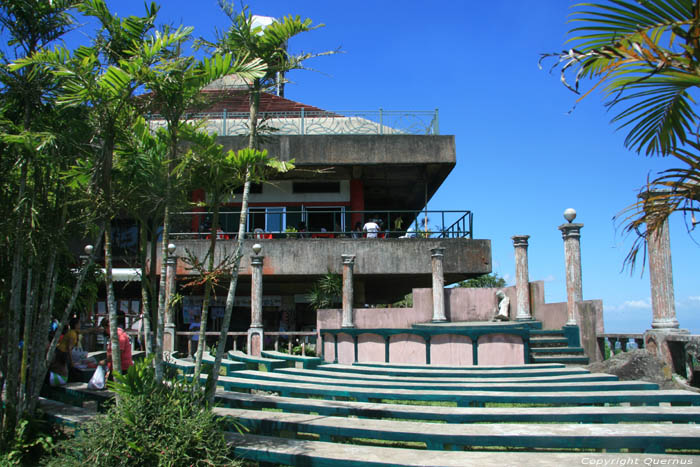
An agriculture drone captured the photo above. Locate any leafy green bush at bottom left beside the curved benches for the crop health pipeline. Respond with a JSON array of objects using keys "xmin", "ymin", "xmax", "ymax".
[{"xmin": 49, "ymin": 361, "xmax": 235, "ymax": 467}]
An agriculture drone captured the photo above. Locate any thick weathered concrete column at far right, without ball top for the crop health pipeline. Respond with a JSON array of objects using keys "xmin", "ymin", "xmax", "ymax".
[{"xmin": 647, "ymin": 212, "xmax": 679, "ymax": 330}]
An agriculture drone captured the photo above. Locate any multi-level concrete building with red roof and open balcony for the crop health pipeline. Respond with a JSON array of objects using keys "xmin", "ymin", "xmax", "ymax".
[{"xmin": 142, "ymin": 78, "xmax": 491, "ymax": 346}]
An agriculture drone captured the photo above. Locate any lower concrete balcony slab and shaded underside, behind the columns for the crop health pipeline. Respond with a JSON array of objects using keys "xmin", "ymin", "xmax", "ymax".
[{"xmin": 157, "ymin": 238, "xmax": 491, "ymax": 303}]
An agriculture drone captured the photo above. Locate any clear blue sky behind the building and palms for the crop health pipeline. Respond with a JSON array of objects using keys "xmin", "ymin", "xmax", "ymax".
[{"xmin": 63, "ymin": 0, "xmax": 700, "ymax": 333}]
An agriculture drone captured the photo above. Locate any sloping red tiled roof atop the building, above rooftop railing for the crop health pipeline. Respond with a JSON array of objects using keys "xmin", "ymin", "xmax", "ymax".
[{"xmin": 199, "ymin": 90, "xmax": 330, "ymax": 113}]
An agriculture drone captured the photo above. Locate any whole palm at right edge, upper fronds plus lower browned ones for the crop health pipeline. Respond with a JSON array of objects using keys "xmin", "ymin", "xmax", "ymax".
[{"xmin": 540, "ymin": 0, "xmax": 700, "ymax": 266}]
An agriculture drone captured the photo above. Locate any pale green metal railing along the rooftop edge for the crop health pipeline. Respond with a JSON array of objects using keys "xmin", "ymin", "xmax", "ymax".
[{"xmin": 148, "ymin": 108, "xmax": 440, "ymax": 136}]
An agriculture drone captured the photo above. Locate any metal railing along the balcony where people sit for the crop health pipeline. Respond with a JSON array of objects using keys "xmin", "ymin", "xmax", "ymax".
[{"xmin": 170, "ymin": 212, "xmax": 473, "ymax": 240}]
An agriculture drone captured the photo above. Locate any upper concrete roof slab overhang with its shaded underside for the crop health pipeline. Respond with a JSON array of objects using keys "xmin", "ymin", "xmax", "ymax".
[{"xmin": 218, "ymin": 134, "xmax": 456, "ymax": 210}]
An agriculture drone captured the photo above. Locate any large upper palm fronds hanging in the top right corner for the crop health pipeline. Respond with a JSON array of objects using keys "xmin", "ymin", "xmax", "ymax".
[{"xmin": 545, "ymin": 0, "xmax": 700, "ymax": 155}]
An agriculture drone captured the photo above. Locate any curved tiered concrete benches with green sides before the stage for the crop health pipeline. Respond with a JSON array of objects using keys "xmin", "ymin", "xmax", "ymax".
[{"xmin": 216, "ymin": 364, "xmax": 700, "ymax": 465}]
